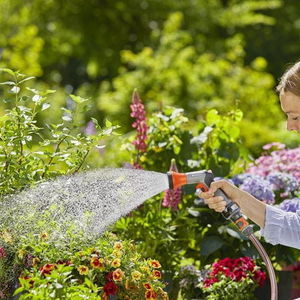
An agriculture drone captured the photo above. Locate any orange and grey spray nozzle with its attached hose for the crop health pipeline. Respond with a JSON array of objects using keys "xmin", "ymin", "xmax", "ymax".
[{"xmin": 167, "ymin": 170, "xmax": 278, "ymax": 300}]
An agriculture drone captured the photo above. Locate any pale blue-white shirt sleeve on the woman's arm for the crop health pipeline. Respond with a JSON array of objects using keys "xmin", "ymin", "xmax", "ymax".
[{"xmin": 261, "ymin": 205, "xmax": 300, "ymax": 249}]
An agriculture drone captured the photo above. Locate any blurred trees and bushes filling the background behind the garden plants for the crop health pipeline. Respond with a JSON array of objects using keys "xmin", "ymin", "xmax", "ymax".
[{"xmin": 0, "ymin": 0, "xmax": 300, "ymax": 156}]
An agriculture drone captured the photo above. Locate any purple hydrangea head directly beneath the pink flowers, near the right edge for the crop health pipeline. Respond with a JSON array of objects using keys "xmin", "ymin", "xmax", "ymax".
[{"xmin": 266, "ymin": 172, "xmax": 299, "ymax": 192}]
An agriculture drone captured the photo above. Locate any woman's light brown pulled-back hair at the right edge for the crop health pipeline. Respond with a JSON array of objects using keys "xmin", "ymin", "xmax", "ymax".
[{"xmin": 276, "ymin": 61, "xmax": 300, "ymax": 96}]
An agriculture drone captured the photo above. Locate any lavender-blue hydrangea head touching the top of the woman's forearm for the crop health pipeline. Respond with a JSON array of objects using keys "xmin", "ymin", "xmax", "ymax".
[{"xmin": 240, "ymin": 177, "xmax": 275, "ymax": 204}]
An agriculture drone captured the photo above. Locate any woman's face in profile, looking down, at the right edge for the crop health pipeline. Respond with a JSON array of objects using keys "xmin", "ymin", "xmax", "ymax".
[{"xmin": 280, "ymin": 92, "xmax": 300, "ymax": 132}]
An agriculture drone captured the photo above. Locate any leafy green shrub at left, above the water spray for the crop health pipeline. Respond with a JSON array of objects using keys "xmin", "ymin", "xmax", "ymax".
[{"xmin": 0, "ymin": 69, "xmax": 116, "ymax": 196}]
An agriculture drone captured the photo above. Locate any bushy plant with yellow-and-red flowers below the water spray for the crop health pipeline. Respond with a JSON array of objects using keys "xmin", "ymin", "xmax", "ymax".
[{"xmin": 15, "ymin": 233, "xmax": 167, "ymax": 300}]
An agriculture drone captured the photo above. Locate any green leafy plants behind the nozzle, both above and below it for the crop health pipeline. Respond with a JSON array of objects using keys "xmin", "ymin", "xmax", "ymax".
[{"xmin": 114, "ymin": 107, "xmax": 249, "ymax": 299}]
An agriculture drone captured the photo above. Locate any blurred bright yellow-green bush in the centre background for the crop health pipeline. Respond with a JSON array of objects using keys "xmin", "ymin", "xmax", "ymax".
[{"xmin": 98, "ymin": 13, "xmax": 280, "ymax": 152}]
